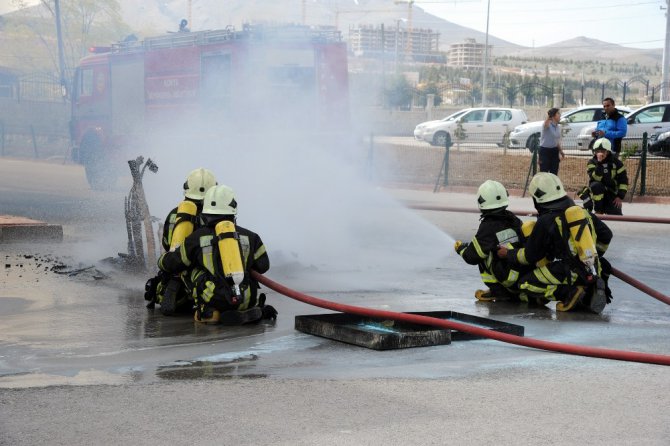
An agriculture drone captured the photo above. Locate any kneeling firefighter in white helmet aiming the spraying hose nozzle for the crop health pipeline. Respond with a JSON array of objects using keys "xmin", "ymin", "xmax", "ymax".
[{"xmin": 454, "ymin": 180, "xmax": 522, "ymax": 301}]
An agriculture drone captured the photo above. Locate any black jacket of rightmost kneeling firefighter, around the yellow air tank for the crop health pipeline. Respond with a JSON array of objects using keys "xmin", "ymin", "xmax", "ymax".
[{"xmin": 507, "ymin": 197, "xmax": 612, "ymax": 265}]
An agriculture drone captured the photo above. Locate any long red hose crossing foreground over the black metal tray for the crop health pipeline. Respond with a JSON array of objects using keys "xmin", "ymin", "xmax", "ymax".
[{"xmin": 251, "ymin": 271, "xmax": 670, "ymax": 365}]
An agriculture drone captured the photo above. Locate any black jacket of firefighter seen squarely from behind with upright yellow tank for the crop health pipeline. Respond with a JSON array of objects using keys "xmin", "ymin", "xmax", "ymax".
[{"xmin": 158, "ymin": 222, "xmax": 270, "ymax": 311}]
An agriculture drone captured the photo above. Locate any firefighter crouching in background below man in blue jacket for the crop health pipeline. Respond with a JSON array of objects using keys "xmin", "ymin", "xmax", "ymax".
[{"xmin": 579, "ymin": 138, "xmax": 628, "ymax": 215}]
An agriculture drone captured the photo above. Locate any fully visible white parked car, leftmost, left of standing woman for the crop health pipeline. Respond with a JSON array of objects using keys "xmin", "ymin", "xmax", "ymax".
[{"xmin": 414, "ymin": 107, "xmax": 528, "ymax": 147}]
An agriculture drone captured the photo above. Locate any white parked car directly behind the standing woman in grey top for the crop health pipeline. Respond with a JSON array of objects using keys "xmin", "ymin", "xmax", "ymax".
[{"xmin": 509, "ymin": 105, "xmax": 631, "ymax": 149}]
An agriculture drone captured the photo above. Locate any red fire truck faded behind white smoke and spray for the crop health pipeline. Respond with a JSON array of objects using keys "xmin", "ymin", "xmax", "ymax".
[{"xmin": 70, "ymin": 25, "xmax": 349, "ymax": 188}]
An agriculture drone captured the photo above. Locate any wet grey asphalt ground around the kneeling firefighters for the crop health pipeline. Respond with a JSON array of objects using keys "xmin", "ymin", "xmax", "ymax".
[{"xmin": 0, "ymin": 161, "xmax": 670, "ymax": 444}]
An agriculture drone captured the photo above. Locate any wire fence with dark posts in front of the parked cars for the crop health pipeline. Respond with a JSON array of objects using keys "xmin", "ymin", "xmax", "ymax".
[{"xmin": 365, "ymin": 134, "xmax": 670, "ymax": 198}]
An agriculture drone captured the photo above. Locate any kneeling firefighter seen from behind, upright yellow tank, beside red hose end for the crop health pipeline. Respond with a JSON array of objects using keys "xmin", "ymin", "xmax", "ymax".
[{"xmin": 158, "ymin": 185, "xmax": 277, "ymax": 325}]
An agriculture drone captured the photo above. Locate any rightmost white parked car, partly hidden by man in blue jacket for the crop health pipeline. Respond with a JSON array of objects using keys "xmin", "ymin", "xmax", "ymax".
[{"xmin": 577, "ymin": 101, "xmax": 670, "ymax": 150}]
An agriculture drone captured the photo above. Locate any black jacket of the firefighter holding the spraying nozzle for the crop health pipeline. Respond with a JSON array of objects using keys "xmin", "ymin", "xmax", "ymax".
[{"xmin": 458, "ymin": 209, "xmax": 523, "ymax": 286}]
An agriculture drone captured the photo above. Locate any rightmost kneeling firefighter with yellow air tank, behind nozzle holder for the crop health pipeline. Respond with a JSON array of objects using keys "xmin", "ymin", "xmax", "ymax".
[{"xmin": 498, "ymin": 172, "xmax": 612, "ymax": 313}]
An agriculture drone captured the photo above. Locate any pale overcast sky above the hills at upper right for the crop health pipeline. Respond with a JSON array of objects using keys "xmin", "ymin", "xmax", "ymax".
[{"xmin": 415, "ymin": 0, "xmax": 667, "ymax": 48}]
